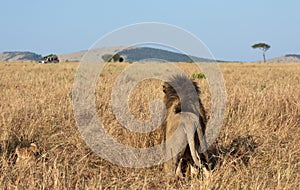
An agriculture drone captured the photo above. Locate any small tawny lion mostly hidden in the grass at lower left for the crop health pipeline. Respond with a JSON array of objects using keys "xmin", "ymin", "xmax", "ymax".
[{"xmin": 16, "ymin": 143, "xmax": 38, "ymax": 165}]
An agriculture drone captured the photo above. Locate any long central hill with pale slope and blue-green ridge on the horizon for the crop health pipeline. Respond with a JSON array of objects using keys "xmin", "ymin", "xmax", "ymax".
[{"xmin": 59, "ymin": 47, "xmax": 215, "ymax": 62}]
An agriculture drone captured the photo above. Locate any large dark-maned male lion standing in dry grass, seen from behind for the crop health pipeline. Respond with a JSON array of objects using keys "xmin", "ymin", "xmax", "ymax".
[{"xmin": 163, "ymin": 75, "xmax": 209, "ymax": 178}]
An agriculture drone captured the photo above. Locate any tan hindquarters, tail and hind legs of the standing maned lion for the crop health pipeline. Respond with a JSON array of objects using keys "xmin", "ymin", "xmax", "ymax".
[{"xmin": 165, "ymin": 112, "xmax": 206, "ymax": 178}]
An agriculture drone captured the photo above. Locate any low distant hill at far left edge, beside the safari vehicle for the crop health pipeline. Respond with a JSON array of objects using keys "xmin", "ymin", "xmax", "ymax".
[{"xmin": 0, "ymin": 51, "xmax": 42, "ymax": 62}]
